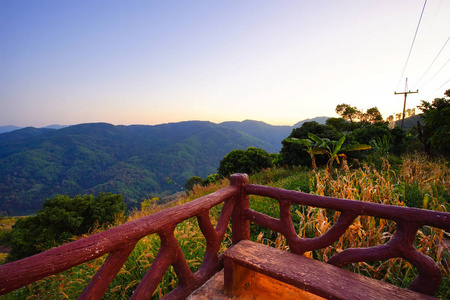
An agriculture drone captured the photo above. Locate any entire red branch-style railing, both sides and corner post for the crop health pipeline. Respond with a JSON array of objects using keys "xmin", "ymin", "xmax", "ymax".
[{"xmin": 0, "ymin": 174, "xmax": 450, "ymax": 299}]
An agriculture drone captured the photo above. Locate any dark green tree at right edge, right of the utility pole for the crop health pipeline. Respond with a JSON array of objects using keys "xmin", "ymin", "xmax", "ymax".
[{"xmin": 418, "ymin": 89, "xmax": 450, "ymax": 157}]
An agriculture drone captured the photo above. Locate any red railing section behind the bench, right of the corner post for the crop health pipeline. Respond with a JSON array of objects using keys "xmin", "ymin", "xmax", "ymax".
[{"xmin": 241, "ymin": 184, "xmax": 450, "ymax": 295}]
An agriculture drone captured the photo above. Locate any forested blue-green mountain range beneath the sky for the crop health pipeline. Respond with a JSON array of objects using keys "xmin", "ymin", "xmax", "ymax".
[{"xmin": 0, "ymin": 121, "xmax": 272, "ymax": 215}]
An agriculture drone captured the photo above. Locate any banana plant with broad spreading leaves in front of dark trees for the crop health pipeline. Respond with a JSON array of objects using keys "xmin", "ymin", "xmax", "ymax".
[{"xmin": 308, "ymin": 132, "xmax": 371, "ymax": 173}]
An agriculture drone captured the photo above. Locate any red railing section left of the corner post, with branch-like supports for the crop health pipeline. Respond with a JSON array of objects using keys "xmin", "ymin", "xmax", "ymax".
[{"xmin": 0, "ymin": 175, "xmax": 248, "ymax": 299}]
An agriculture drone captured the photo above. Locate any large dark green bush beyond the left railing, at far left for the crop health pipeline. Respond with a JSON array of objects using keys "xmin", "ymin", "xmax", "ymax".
[{"xmin": 7, "ymin": 193, "xmax": 126, "ymax": 261}]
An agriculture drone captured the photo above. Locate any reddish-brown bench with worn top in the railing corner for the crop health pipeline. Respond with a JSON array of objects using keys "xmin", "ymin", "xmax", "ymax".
[{"xmin": 224, "ymin": 240, "xmax": 436, "ymax": 300}]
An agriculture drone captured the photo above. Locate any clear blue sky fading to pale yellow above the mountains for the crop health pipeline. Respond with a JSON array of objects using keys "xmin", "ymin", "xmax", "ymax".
[{"xmin": 0, "ymin": 0, "xmax": 450, "ymax": 127}]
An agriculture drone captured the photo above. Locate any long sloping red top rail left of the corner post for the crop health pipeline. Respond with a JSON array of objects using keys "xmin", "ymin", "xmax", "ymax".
[{"xmin": 0, "ymin": 186, "xmax": 239, "ymax": 295}]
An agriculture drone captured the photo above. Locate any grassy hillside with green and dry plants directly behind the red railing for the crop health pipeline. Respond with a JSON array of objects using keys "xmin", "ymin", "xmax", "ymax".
[{"xmin": 0, "ymin": 155, "xmax": 450, "ymax": 299}]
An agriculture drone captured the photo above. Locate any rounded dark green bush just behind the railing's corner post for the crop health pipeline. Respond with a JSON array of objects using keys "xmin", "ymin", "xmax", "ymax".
[{"xmin": 217, "ymin": 147, "xmax": 273, "ymax": 177}]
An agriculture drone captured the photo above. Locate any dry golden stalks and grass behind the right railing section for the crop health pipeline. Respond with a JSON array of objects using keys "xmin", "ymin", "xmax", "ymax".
[{"xmin": 299, "ymin": 155, "xmax": 450, "ymax": 287}]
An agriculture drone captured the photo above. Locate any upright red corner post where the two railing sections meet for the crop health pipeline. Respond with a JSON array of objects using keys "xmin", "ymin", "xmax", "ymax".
[{"xmin": 230, "ymin": 174, "xmax": 250, "ymax": 244}]
